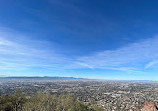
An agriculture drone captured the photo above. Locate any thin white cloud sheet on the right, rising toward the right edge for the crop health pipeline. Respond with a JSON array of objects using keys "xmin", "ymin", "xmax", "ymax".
[{"xmin": 74, "ymin": 37, "xmax": 158, "ymax": 71}]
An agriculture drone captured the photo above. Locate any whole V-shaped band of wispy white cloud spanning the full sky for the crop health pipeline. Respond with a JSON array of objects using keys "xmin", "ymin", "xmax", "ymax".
[{"xmin": 0, "ymin": 27, "xmax": 158, "ymax": 73}]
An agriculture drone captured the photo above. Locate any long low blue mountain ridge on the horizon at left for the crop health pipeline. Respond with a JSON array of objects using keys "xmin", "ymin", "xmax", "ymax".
[{"xmin": 0, "ymin": 76, "xmax": 88, "ymax": 80}]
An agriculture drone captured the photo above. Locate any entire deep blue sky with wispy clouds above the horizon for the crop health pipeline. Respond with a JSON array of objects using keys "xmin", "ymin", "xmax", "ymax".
[{"xmin": 0, "ymin": 0, "xmax": 158, "ymax": 80}]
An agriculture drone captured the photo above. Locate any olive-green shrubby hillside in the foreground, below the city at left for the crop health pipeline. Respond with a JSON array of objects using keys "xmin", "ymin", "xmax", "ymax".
[{"xmin": 0, "ymin": 93, "xmax": 102, "ymax": 111}]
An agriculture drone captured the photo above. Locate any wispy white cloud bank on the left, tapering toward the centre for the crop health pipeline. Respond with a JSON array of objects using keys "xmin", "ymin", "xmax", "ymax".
[{"xmin": 0, "ymin": 28, "xmax": 71, "ymax": 70}]
